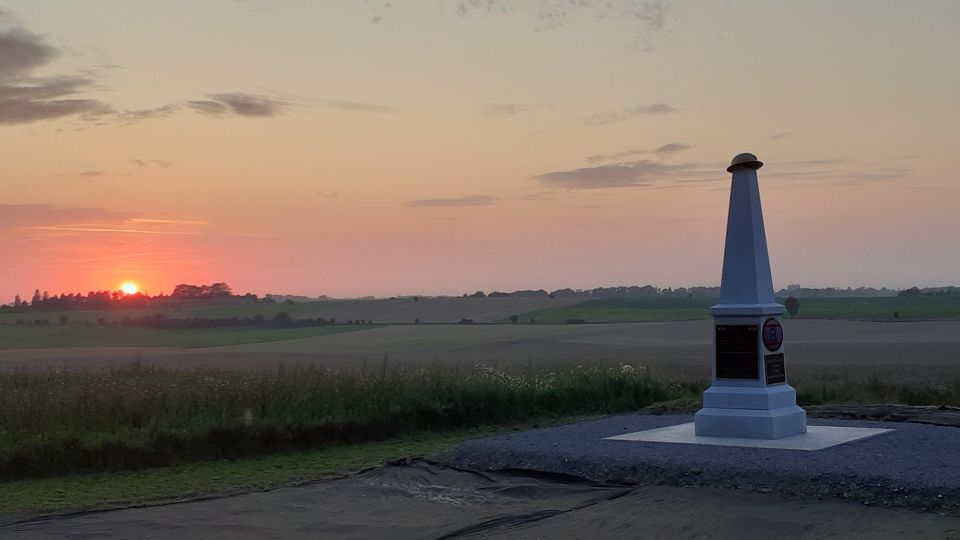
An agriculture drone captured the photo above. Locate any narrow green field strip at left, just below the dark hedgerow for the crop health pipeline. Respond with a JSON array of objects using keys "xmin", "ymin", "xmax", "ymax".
[{"xmin": 0, "ymin": 324, "xmax": 375, "ymax": 349}]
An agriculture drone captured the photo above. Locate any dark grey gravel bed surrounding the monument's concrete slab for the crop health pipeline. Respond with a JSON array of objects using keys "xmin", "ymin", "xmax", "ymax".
[{"xmin": 442, "ymin": 415, "xmax": 960, "ymax": 515}]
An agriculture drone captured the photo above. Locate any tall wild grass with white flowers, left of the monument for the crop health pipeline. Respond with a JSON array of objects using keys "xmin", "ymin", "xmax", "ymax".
[{"xmin": 0, "ymin": 364, "xmax": 676, "ymax": 480}]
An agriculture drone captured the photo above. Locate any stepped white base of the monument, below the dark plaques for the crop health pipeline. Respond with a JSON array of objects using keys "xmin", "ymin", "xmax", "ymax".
[{"xmin": 694, "ymin": 384, "xmax": 807, "ymax": 439}]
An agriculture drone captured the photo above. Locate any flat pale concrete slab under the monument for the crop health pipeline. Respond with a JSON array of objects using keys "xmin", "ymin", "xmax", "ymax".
[{"xmin": 604, "ymin": 422, "xmax": 893, "ymax": 450}]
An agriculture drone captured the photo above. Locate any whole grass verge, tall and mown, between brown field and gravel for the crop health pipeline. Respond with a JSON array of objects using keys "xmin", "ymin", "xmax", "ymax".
[{"xmin": 0, "ymin": 358, "xmax": 960, "ymax": 516}]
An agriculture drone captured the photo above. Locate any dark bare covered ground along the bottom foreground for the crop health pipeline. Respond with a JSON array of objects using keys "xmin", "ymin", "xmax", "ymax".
[{"xmin": 0, "ymin": 462, "xmax": 960, "ymax": 539}]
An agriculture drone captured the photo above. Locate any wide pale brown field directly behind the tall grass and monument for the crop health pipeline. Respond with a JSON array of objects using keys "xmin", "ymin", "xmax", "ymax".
[{"xmin": 0, "ymin": 320, "xmax": 960, "ymax": 373}]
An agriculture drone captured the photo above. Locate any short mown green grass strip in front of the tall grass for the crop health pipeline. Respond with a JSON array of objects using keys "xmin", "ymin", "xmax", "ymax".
[{"xmin": 0, "ymin": 426, "xmax": 532, "ymax": 518}]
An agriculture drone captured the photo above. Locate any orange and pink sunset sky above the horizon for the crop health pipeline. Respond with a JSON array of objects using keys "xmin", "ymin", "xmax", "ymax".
[{"xmin": 0, "ymin": 0, "xmax": 960, "ymax": 302}]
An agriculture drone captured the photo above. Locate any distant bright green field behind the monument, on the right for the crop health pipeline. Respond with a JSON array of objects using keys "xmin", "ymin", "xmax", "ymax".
[{"xmin": 520, "ymin": 295, "xmax": 960, "ymax": 323}]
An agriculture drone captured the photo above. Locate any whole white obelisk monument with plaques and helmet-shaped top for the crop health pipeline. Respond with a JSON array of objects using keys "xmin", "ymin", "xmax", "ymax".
[{"xmin": 694, "ymin": 154, "xmax": 807, "ymax": 439}]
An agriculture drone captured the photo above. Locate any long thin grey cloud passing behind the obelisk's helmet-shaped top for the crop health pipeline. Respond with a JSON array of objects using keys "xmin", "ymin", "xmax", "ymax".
[{"xmin": 533, "ymin": 159, "xmax": 911, "ymax": 190}]
